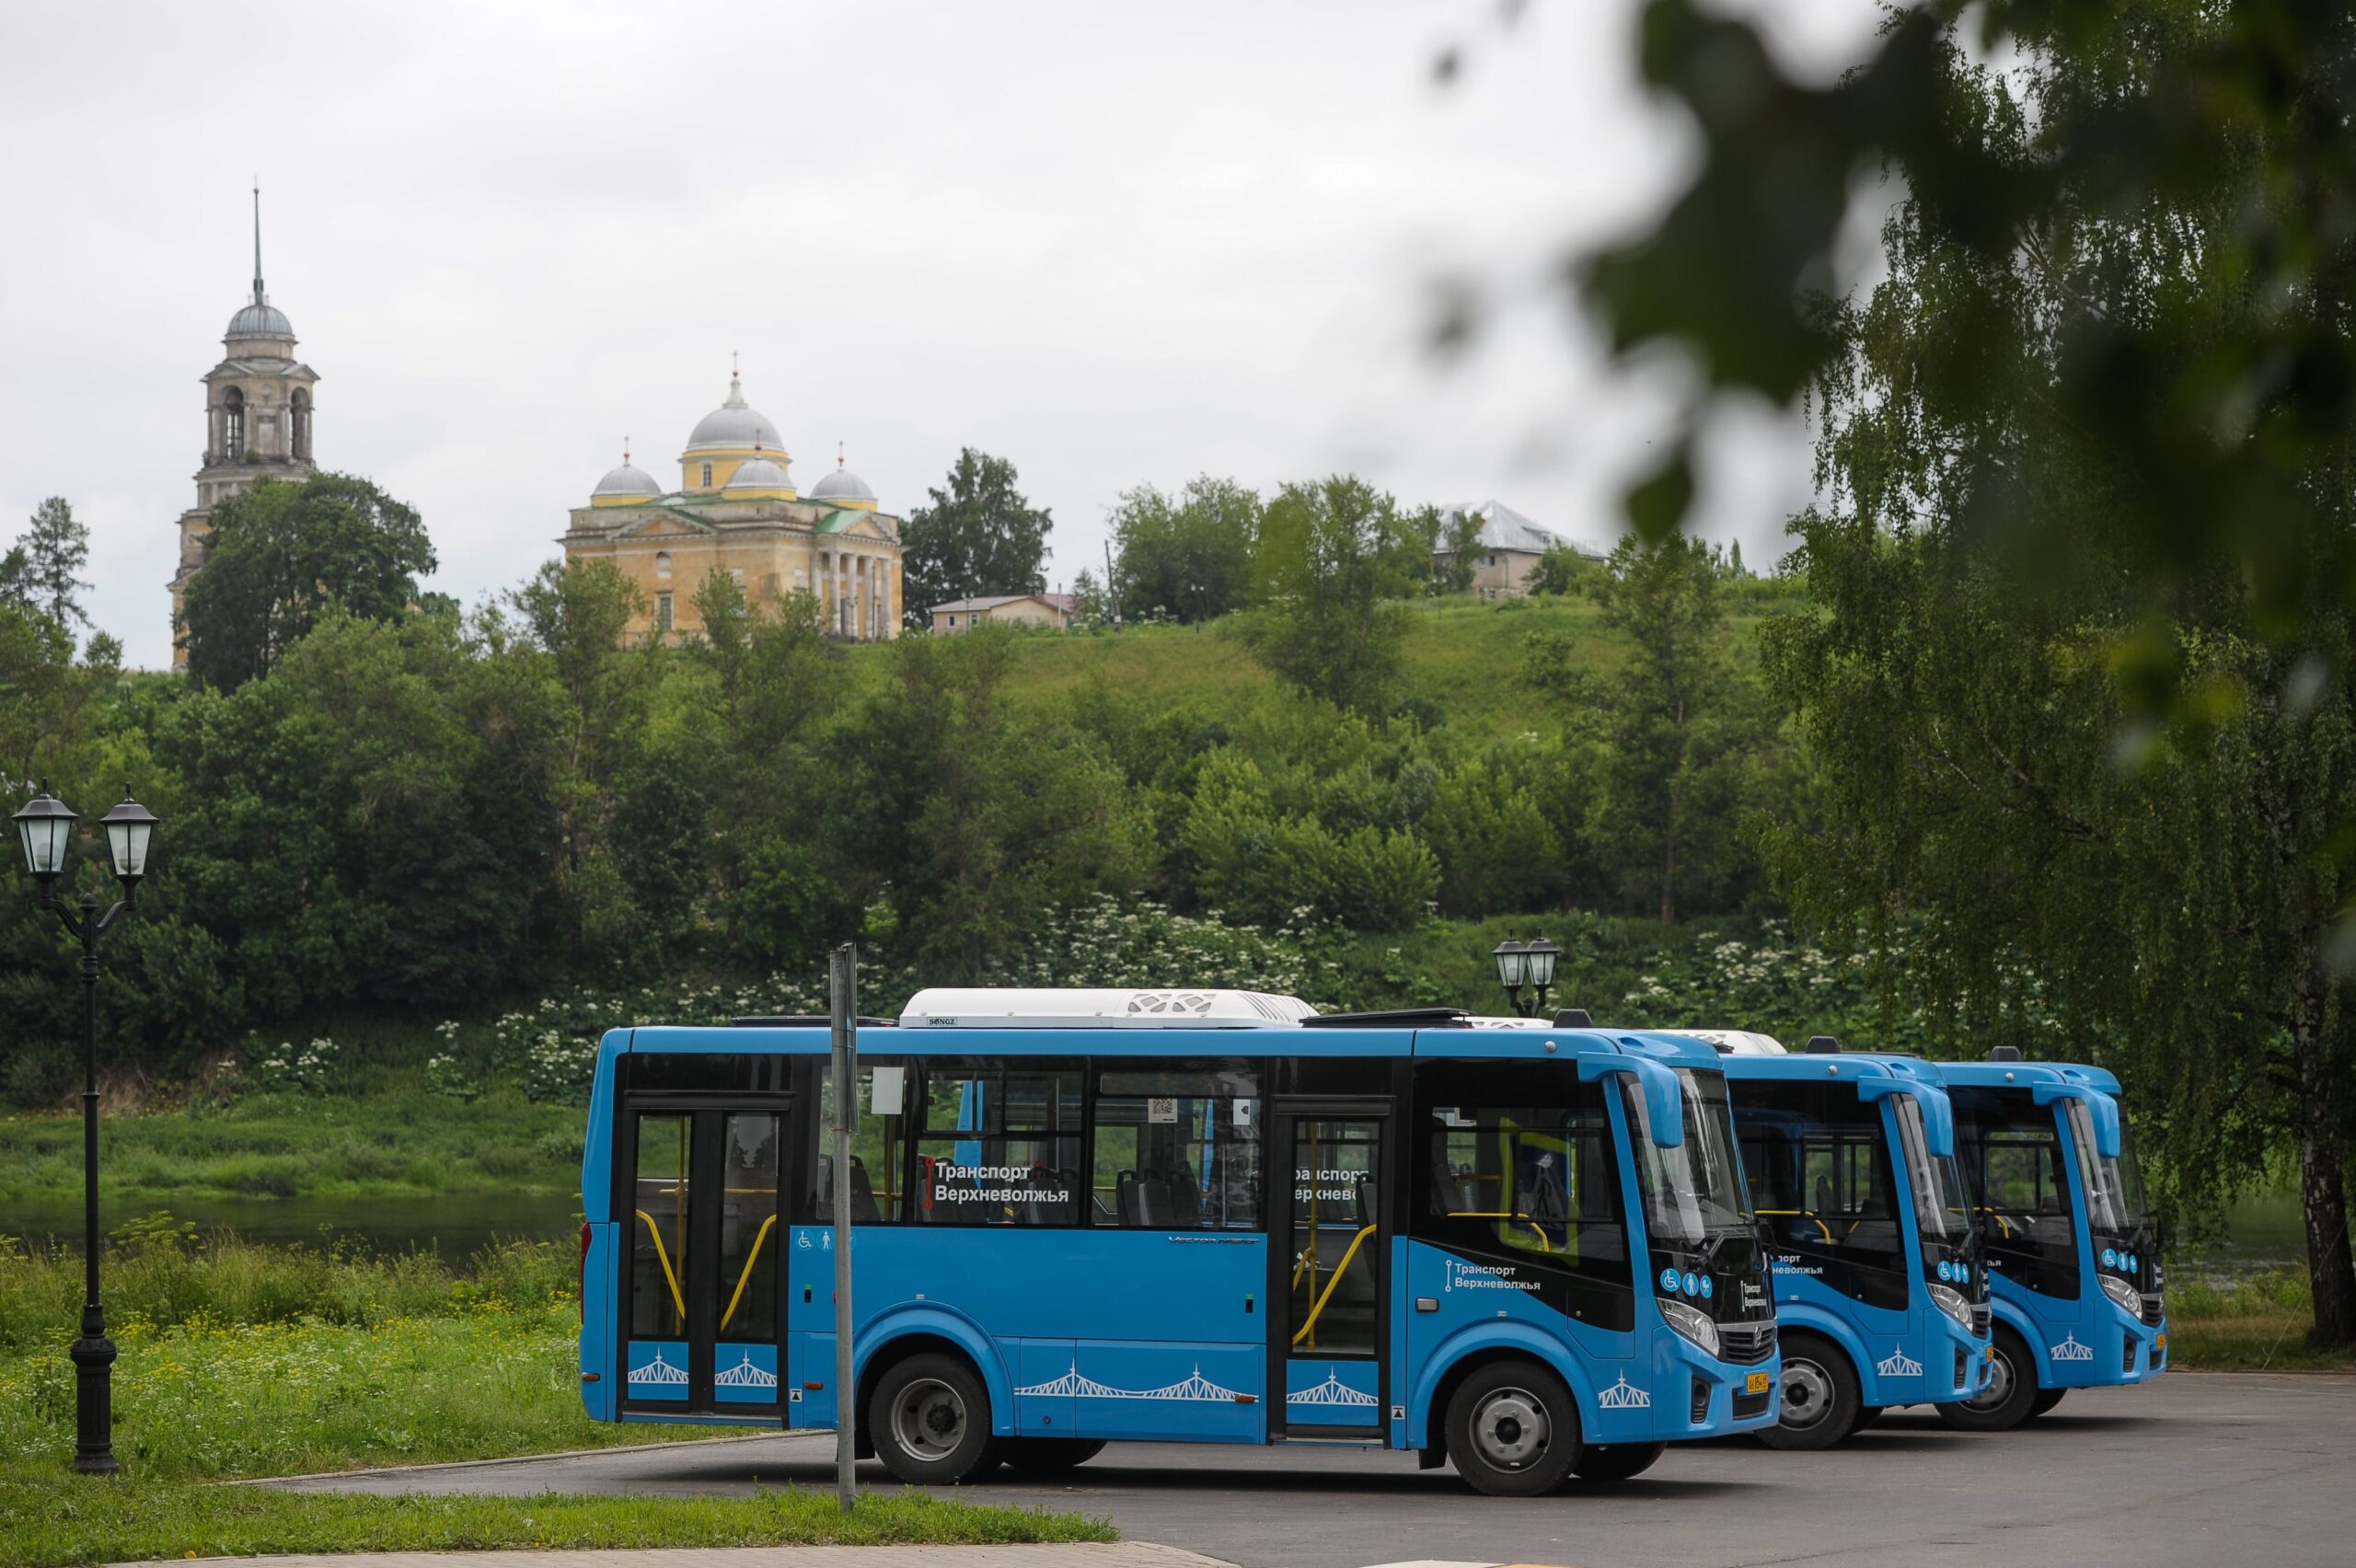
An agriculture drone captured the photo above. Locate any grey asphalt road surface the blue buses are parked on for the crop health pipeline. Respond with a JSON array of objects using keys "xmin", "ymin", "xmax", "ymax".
[{"xmin": 281, "ymin": 1373, "xmax": 2356, "ymax": 1568}]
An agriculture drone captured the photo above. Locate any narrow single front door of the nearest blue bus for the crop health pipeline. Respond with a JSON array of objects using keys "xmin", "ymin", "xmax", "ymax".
[{"xmin": 1267, "ymin": 1101, "xmax": 1392, "ymax": 1438}]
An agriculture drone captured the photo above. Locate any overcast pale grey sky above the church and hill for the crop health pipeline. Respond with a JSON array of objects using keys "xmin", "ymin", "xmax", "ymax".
[{"xmin": 0, "ymin": 0, "xmax": 1873, "ymax": 666}]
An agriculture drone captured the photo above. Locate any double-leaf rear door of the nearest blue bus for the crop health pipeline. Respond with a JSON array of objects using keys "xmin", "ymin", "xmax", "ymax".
[{"xmin": 619, "ymin": 1100, "xmax": 791, "ymax": 1417}]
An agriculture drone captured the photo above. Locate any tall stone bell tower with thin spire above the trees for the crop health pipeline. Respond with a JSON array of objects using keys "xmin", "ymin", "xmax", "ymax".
[{"xmin": 169, "ymin": 186, "xmax": 318, "ymax": 669}]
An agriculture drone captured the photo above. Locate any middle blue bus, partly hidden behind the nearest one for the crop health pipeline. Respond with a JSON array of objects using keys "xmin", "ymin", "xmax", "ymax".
[{"xmin": 1696, "ymin": 1033, "xmax": 1993, "ymax": 1448}]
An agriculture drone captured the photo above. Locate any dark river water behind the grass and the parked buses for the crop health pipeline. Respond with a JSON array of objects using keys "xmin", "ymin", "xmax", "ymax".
[{"xmin": 0, "ymin": 1193, "xmax": 2306, "ymax": 1281}]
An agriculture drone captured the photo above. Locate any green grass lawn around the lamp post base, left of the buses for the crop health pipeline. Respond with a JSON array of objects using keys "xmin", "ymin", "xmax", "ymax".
[{"xmin": 0, "ymin": 1304, "xmax": 1114, "ymax": 1565}]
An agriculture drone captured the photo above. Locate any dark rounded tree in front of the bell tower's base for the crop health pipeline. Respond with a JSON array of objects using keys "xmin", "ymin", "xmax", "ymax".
[{"xmin": 179, "ymin": 473, "xmax": 436, "ymax": 690}]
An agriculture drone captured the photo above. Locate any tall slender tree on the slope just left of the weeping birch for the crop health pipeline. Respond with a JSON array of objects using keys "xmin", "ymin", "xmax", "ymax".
[{"xmin": 1522, "ymin": 535, "xmax": 1772, "ymax": 926}]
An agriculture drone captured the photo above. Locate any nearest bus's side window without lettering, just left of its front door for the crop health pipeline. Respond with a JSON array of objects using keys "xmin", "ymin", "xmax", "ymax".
[{"xmin": 1089, "ymin": 1062, "xmax": 1261, "ymax": 1231}]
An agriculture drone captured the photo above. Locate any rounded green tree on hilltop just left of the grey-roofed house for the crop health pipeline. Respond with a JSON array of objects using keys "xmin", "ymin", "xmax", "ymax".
[{"xmin": 1244, "ymin": 473, "xmax": 1427, "ymax": 713}]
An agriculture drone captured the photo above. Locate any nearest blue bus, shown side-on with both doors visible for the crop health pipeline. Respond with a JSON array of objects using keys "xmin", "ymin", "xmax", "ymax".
[{"xmin": 580, "ymin": 991, "xmax": 1776, "ymax": 1495}]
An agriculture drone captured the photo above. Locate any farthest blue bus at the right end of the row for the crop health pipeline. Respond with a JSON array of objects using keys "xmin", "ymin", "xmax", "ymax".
[{"xmin": 1939, "ymin": 1048, "xmax": 2167, "ymax": 1432}]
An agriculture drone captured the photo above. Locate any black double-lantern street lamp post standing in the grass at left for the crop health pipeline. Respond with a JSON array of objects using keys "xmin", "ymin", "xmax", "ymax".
[{"xmin": 17, "ymin": 789, "xmax": 156, "ymax": 1476}]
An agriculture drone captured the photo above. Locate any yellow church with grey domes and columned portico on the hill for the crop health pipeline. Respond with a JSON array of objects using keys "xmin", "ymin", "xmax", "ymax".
[{"xmin": 560, "ymin": 357, "xmax": 902, "ymax": 642}]
